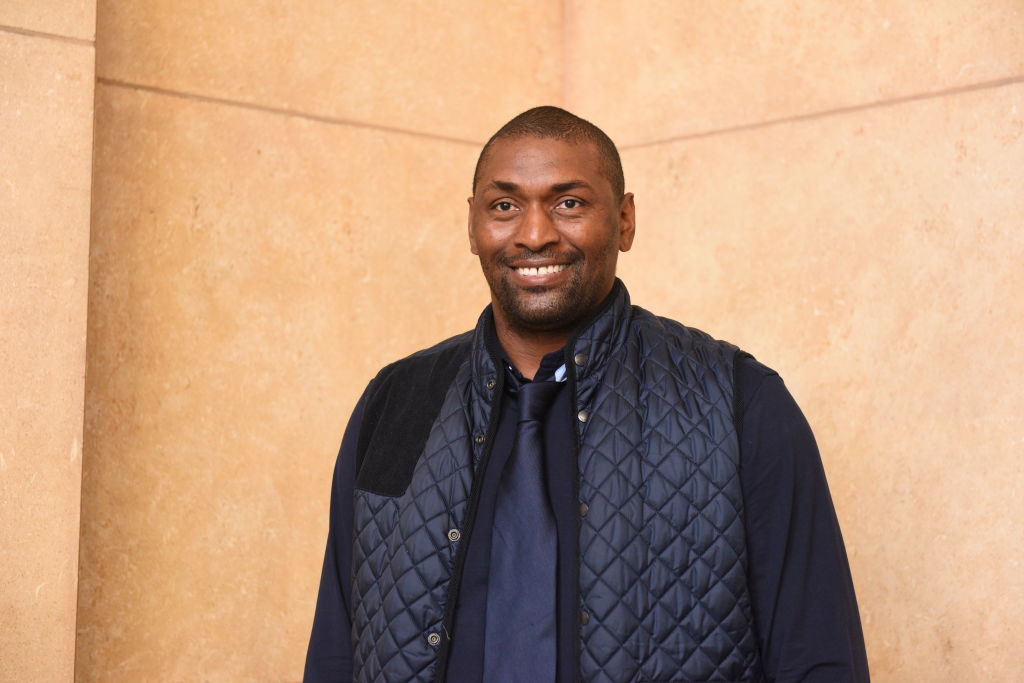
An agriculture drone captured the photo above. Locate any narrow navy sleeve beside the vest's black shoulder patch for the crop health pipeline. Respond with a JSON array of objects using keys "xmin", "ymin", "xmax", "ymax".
[{"xmin": 302, "ymin": 394, "xmax": 366, "ymax": 683}]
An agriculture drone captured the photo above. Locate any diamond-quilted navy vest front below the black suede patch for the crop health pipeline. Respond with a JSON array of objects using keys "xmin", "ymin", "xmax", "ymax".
[{"xmin": 352, "ymin": 364, "xmax": 481, "ymax": 683}]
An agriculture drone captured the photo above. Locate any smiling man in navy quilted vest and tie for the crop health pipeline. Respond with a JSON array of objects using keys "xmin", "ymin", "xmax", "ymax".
[{"xmin": 306, "ymin": 106, "xmax": 867, "ymax": 683}]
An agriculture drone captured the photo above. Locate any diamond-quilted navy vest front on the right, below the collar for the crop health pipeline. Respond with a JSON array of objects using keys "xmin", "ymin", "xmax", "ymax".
[{"xmin": 574, "ymin": 307, "xmax": 761, "ymax": 681}]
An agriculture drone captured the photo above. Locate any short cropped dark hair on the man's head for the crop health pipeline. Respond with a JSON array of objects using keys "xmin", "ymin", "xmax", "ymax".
[{"xmin": 473, "ymin": 105, "xmax": 626, "ymax": 198}]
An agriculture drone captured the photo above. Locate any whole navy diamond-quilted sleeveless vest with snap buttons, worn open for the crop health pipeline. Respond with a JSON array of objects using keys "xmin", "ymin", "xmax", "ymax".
[{"xmin": 352, "ymin": 282, "xmax": 762, "ymax": 683}]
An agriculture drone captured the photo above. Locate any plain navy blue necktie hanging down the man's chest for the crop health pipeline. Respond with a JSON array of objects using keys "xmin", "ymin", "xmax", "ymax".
[{"xmin": 483, "ymin": 382, "xmax": 560, "ymax": 683}]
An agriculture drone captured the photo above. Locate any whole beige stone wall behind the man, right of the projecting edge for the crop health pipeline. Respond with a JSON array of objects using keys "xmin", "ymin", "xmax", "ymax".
[{"xmin": 64, "ymin": 0, "xmax": 1024, "ymax": 681}]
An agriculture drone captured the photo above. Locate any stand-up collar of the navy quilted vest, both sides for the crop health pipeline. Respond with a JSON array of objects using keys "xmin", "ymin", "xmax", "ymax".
[{"xmin": 472, "ymin": 278, "xmax": 633, "ymax": 395}]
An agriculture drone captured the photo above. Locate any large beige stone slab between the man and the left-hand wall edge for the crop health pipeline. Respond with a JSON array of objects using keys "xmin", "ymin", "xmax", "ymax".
[{"xmin": 78, "ymin": 85, "xmax": 486, "ymax": 681}]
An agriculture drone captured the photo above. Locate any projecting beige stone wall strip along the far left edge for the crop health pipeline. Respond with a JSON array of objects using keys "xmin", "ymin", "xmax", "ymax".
[{"xmin": 0, "ymin": 1, "xmax": 94, "ymax": 682}]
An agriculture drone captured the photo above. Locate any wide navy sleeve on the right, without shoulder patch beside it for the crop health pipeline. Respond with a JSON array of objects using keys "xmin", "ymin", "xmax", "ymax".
[{"xmin": 736, "ymin": 357, "xmax": 869, "ymax": 683}]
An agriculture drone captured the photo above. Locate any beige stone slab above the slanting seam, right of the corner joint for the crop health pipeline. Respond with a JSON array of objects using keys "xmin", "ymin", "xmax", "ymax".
[{"xmin": 565, "ymin": 0, "xmax": 1024, "ymax": 144}]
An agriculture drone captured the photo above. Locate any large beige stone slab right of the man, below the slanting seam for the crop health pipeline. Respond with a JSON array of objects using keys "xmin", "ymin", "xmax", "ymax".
[{"xmin": 622, "ymin": 84, "xmax": 1024, "ymax": 681}]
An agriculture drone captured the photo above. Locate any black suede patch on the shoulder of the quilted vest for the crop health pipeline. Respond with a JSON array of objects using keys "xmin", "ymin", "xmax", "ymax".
[{"xmin": 355, "ymin": 332, "xmax": 472, "ymax": 496}]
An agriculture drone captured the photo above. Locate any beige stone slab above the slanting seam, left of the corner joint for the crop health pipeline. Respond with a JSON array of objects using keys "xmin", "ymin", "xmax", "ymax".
[{"xmin": 97, "ymin": 0, "xmax": 562, "ymax": 142}]
